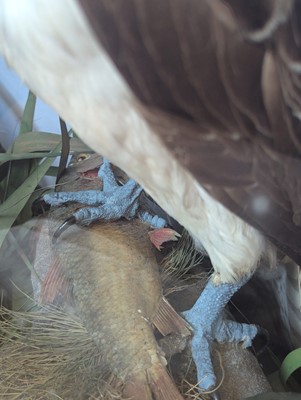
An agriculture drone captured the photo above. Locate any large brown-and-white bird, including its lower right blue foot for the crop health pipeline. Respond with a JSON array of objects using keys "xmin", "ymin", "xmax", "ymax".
[{"xmin": 0, "ymin": 0, "xmax": 301, "ymax": 396}]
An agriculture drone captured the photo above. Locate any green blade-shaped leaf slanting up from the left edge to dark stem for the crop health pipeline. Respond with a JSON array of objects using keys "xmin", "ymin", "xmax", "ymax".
[{"xmin": 0, "ymin": 144, "xmax": 60, "ymax": 247}]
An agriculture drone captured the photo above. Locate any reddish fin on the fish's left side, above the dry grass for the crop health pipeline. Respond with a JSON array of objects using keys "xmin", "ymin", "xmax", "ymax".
[{"xmin": 40, "ymin": 258, "xmax": 71, "ymax": 304}]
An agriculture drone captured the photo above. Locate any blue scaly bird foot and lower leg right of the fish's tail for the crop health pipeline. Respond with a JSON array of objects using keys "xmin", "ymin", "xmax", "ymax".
[{"xmin": 183, "ymin": 276, "xmax": 258, "ymax": 392}]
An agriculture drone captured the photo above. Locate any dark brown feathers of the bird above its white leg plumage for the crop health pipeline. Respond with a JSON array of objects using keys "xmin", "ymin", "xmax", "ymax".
[{"xmin": 78, "ymin": 0, "xmax": 301, "ymax": 263}]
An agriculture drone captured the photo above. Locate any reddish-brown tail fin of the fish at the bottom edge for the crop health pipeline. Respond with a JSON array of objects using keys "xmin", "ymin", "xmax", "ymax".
[{"xmin": 123, "ymin": 364, "xmax": 184, "ymax": 400}]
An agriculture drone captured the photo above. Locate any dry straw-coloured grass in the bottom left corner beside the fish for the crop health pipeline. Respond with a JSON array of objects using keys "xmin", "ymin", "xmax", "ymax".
[{"xmin": 0, "ymin": 307, "xmax": 120, "ymax": 400}]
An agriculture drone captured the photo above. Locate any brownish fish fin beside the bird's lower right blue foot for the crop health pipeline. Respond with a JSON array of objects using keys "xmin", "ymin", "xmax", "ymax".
[{"xmin": 153, "ymin": 297, "xmax": 191, "ymax": 336}]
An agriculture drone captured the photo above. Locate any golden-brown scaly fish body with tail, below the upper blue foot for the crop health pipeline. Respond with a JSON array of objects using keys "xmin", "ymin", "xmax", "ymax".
[{"xmin": 54, "ymin": 221, "xmax": 182, "ymax": 400}]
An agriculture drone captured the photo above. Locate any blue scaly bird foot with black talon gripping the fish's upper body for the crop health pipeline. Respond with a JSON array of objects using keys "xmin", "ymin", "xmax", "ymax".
[{"xmin": 43, "ymin": 159, "xmax": 165, "ymax": 228}]
